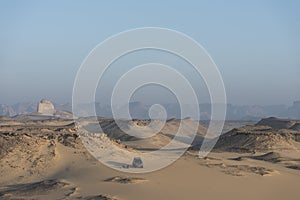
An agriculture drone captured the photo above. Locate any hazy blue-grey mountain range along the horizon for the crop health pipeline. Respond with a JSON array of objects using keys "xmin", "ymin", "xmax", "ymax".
[{"xmin": 0, "ymin": 101, "xmax": 300, "ymax": 121}]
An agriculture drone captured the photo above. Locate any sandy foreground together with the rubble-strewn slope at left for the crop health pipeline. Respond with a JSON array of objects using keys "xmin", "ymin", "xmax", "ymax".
[{"xmin": 0, "ymin": 118, "xmax": 300, "ymax": 200}]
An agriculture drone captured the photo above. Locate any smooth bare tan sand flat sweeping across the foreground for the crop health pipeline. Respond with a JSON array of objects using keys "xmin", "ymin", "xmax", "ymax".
[{"xmin": 1, "ymin": 145, "xmax": 300, "ymax": 200}]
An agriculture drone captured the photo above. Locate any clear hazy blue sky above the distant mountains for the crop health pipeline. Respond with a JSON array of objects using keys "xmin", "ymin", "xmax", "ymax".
[{"xmin": 0, "ymin": 0, "xmax": 300, "ymax": 105}]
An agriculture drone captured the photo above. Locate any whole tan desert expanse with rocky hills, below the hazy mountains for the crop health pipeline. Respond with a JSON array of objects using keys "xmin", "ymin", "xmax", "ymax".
[{"xmin": 0, "ymin": 113, "xmax": 300, "ymax": 199}]
